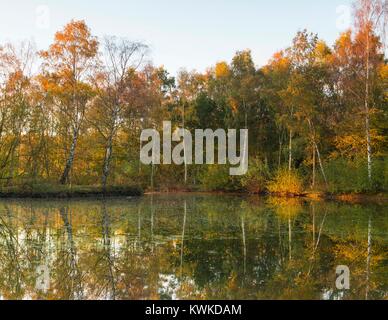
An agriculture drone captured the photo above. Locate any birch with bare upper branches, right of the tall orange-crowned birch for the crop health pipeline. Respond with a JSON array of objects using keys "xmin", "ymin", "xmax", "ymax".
[{"xmin": 90, "ymin": 37, "xmax": 147, "ymax": 190}]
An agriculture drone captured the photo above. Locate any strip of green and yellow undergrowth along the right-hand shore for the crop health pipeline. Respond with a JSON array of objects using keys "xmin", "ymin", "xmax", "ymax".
[{"xmin": 187, "ymin": 159, "xmax": 388, "ymax": 199}]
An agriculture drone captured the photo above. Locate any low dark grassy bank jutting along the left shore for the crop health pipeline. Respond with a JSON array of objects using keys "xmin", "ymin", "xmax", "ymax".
[{"xmin": 0, "ymin": 184, "xmax": 143, "ymax": 199}]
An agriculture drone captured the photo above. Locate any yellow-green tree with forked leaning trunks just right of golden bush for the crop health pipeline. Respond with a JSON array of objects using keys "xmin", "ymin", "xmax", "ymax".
[{"xmin": 284, "ymin": 31, "xmax": 330, "ymax": 186}]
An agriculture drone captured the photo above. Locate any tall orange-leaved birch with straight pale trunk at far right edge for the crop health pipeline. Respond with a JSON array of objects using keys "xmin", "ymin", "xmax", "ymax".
[{"xmin": 332, "ymin": 0, "xmax": 387, "ymax": 187}]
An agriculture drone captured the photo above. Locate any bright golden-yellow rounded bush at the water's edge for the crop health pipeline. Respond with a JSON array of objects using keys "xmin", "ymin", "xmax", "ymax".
[{"xmin": 268, "ymin": 168, "xmax": 303, "ymax": 195}]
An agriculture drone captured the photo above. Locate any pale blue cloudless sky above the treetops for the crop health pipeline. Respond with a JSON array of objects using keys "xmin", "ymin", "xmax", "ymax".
[{"xmin": 0, "ymin": 0, "xmax": 351, "ymax": 74}]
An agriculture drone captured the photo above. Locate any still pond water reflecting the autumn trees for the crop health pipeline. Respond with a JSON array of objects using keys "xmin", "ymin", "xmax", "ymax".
[{"xmin": 0, "ymin": 195, "xmax": 388, "ymax": 299}]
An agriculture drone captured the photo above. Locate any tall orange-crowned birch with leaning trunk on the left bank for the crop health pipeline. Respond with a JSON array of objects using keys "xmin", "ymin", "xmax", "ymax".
[{"xmin": 40, "ymin": 20, "xmax": 98, "ymax": 184}]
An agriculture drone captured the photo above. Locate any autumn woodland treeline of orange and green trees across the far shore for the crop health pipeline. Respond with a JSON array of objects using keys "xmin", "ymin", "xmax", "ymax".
[{"xmin": 0, "ymin": 0, "xmax": 388, "ymax": 194}]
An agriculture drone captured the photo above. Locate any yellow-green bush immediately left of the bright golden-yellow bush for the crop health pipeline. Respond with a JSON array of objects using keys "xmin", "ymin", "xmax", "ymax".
[{"xmin": 241, "ymin": 158, "xmax": 270, "ymax": 194}]
